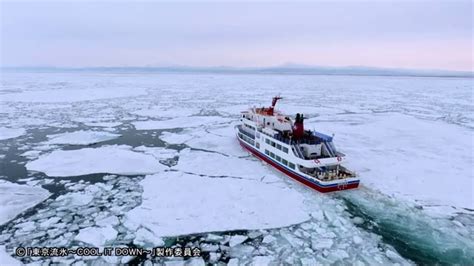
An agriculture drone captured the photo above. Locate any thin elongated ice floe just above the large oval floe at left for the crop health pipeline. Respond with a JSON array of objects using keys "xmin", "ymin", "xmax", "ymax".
[{"xmin": 46, "ymin": 130, "xmax": 120, "ymax": 145}]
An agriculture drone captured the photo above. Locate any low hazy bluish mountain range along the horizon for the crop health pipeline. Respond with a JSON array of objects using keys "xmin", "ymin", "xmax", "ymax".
[{"xmin": 1, "ymin": 63, "xmax": 474, "ymax": 78}]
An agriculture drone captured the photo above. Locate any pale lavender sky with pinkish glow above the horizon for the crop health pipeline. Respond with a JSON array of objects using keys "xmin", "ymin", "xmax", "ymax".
[{"xmin": 0, "ymin": 0, "xmax": 473, "ymax": 71}]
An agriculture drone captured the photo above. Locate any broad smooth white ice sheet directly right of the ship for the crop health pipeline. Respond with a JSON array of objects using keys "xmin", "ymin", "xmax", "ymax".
[{"xmin": 307, "ymin": 113, "xmax": 474, "ymax": 213}]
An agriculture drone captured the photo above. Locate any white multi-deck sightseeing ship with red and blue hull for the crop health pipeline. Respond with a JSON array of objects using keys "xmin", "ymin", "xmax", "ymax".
[{"xmin": 235, "ymin": 97, "xmax": 359, "ymax": 192}]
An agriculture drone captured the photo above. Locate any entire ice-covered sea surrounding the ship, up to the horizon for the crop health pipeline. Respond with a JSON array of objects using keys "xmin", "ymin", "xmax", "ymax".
[{"xmin": 0, "ymin": 71, "xmax": 474, "ymax": 265}]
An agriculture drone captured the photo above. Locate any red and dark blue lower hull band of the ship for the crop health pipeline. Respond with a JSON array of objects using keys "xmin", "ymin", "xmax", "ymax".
[{"xmin": 237, "ymin": 138, "xmax": 359, "ymax": 192}]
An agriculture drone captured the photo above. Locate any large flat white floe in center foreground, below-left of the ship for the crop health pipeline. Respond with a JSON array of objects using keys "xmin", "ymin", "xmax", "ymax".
[{"xmin": 127, "ymin": 172, "xmax": 309, "ymax": 236}]
